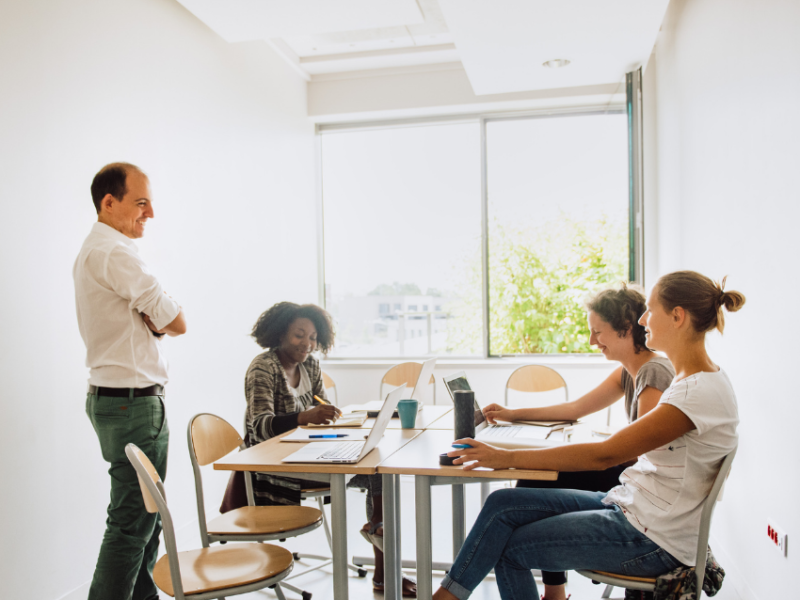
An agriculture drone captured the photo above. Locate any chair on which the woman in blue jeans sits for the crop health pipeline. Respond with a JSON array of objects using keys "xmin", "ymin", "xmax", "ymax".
[{"xmin": 577, "ymin": 448, "xmax": 737, "ymax": 600}]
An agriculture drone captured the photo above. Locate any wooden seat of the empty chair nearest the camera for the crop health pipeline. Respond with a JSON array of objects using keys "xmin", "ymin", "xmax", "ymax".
[{"xmin": 153, "ymin": 544, "xmax": 293, "ymax": 596}]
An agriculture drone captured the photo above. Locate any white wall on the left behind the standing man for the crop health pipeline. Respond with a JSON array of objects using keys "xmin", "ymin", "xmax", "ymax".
[{"xmin": 0, "ymin": 0, "xmax": 317, "ymax": 600}]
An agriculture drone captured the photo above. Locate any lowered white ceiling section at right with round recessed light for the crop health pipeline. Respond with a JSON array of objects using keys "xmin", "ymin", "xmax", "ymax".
[{"xmin": 439, "ymin": 0, "xmax": 669, "ymax": 95}]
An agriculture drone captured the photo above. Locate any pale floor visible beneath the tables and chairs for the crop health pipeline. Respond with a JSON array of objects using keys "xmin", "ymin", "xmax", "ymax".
[{"xmin": 161, "ymin": 477, "xmax": 738, "ymax": 600}]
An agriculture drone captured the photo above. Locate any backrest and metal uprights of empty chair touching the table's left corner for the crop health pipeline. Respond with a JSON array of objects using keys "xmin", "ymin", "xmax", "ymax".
[{"xmin": 186, "ymin": 413, "xmax": 254, "ymax": 548}]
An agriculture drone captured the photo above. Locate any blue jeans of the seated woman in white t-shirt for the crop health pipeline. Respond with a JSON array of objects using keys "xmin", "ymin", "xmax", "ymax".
[{"xmin": 442, "ymin": 488, "xmax": 681, "ymax": 600}]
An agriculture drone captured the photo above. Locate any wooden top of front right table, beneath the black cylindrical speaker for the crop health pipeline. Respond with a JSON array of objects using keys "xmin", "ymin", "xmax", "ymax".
[{"xmin": 378, "ymin": 429, "xmax": 558, "ymax": 481}]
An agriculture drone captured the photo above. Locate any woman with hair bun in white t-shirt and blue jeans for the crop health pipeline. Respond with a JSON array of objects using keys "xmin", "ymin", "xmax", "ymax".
[{"xmin": 434, "ymin": 271, "xmax": 745, "ymax": 600}]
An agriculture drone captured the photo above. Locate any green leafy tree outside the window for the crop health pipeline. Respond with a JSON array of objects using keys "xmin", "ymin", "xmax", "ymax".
[{"xmin": 448, "ymin": 215, "xmax": 628, "ymax": 355}]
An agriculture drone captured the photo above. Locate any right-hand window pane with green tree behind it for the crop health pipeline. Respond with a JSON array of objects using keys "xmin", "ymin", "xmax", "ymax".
[{"xmin": 486, "ymin": 114, "xmax": 629, "ymax": 355}]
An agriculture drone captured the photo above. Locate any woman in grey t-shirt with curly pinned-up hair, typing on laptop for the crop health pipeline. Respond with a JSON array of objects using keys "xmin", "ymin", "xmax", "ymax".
[{"xmin": 483, "ymin": 283, "xmax": 675, "ymax": 600}]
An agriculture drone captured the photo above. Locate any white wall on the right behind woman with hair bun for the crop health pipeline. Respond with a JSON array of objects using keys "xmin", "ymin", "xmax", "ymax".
[{"xmin": 645, "ymin": 0, "xmax": 800, "ymax": 600}]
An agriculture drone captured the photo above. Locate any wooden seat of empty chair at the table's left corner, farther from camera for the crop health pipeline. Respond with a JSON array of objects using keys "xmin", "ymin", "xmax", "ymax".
[{"xmin": 207, "ymin": 506, "xmax": 322, "ymax": 535}]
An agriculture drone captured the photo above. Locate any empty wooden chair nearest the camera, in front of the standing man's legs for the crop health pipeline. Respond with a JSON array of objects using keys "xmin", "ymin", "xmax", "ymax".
[{"xmin": 125, "ymin": 444, "xmax": 294, "ymax": 600}]
